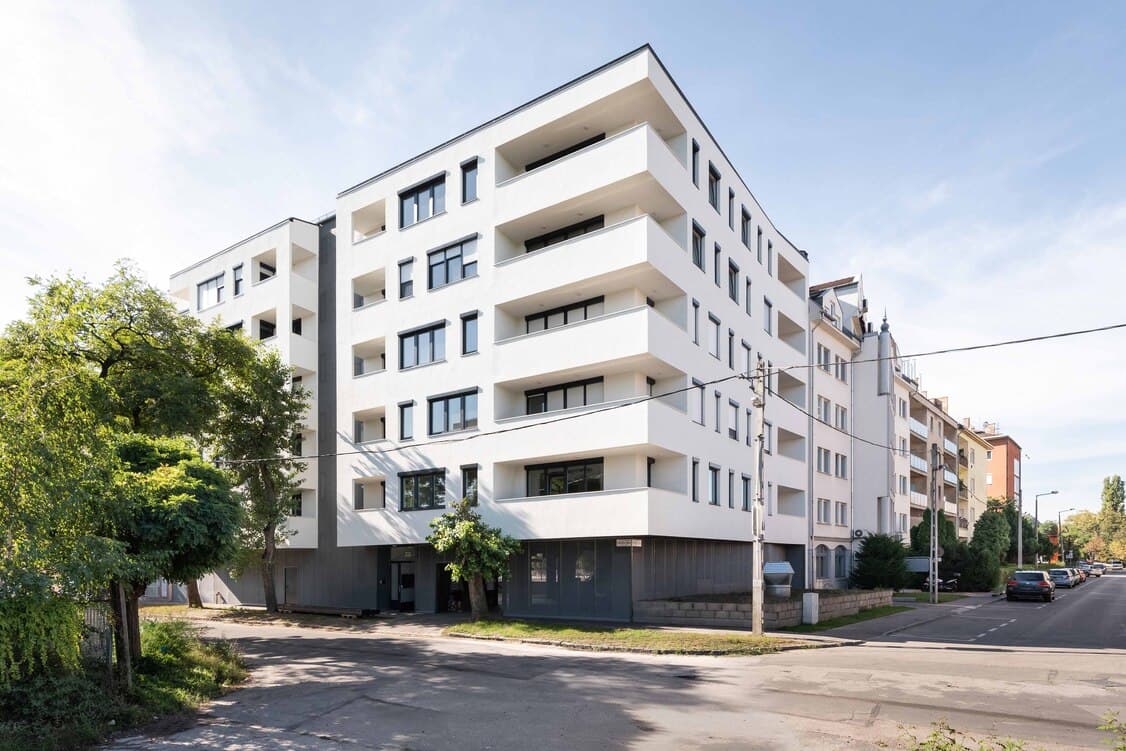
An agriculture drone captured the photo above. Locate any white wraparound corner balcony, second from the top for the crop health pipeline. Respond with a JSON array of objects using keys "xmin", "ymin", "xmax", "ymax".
[{"xmin": 494, "ymin": 215, "xmax": 685, "ymax": 305}]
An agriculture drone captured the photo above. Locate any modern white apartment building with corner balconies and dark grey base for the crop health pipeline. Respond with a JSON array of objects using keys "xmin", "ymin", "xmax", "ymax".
[{"xmin": 172, "ymin": 45, "xmax": 815, "ymax": 620}]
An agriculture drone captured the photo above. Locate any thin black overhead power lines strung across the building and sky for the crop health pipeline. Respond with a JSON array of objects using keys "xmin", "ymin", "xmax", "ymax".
[{"xmin": 216, "ymin": 323, "xmax": 1126, "ymax": 466}]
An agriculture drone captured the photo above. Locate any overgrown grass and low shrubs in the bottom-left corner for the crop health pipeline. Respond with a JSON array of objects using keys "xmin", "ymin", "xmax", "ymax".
[{"xmin": 0, "ymin": 620, "xmax": 247, "ymax": 751}]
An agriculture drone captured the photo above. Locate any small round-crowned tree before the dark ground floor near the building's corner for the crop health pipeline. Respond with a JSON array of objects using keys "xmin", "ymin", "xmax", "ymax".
[{"xmin": 427, "ymin": 499, "xmax": 520, "ymax": 619}]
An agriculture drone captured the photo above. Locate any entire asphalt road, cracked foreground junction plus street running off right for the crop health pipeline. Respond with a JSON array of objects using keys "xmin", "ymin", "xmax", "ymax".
[{"xmin": 110, "ymin": 576, "xmax": 1126, "ymax": 751}]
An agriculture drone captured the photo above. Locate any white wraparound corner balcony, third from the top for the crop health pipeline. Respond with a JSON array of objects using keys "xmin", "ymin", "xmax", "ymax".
[{"xmin": 493, "ymin": 305, "xmax": 691, "ymax": 382}]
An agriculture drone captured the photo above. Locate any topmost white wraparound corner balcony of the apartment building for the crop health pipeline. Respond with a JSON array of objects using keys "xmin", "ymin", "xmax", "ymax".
[{"xmin": 495, "ymin": 123, "xmax": 685, "ymax": 230}]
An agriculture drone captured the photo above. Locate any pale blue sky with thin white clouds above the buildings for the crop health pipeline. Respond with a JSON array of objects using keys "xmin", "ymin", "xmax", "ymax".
[{"xmin": 0, "ymin": 2, "xmax": 1126, "ymax": 516}]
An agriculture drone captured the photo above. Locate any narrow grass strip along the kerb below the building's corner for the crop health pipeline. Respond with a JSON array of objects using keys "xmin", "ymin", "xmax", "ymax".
[{"xmin": 444, "ymin": 619, "xmax": 806, "ymax": 655}]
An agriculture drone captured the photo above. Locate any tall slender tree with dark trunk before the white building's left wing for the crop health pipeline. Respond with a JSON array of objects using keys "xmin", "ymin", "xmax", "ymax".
[{"xmin": 212, "ymin": 346, "xmax": 309, "ymax": 613}]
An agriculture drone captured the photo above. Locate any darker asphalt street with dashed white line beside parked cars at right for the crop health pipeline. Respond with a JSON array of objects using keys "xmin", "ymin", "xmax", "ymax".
[{"xmin": 826, "ymin": 572, "xmax": 1126, "ymax": 650}]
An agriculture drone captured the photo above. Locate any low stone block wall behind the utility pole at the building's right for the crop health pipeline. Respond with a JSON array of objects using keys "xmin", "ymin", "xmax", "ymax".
[{"xmin": 634, "ymin": 589, "xmax": 892, "ymax": 631}]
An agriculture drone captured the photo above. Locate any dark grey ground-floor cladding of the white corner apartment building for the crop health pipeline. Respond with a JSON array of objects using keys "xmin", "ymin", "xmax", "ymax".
[{"xmin": 200, "ymin": 537, "xmax": 788, "ymax": 620}]
